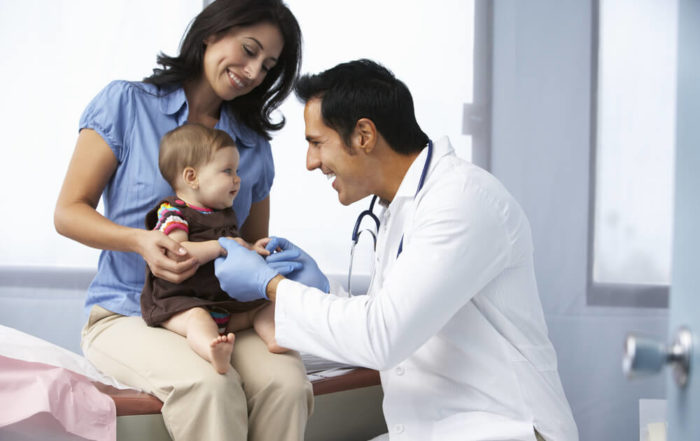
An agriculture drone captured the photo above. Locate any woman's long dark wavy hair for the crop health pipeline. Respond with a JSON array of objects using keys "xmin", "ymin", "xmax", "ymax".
[{"xmin": 144, "ymin": 0, "xmax": 301, "ymax": 140}]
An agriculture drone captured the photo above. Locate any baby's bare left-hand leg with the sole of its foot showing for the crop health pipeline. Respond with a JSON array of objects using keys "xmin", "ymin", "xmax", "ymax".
[{"xmin": 163, "ymin": 308, "xmax": 236, "ymax": 374}]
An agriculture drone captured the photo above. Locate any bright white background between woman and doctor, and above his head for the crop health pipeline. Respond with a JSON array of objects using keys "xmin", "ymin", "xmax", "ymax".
[{"xmin": 270, "ymin": 0, "xmax": 473, "ymax": 274}]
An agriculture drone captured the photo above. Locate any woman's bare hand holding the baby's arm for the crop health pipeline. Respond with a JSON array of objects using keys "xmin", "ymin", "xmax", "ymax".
[{"xmin": 137, "ymin": 230, "xmax": 199, "ymax": 283}]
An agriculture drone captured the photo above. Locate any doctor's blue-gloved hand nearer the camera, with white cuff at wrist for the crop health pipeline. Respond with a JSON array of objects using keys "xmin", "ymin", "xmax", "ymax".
[{"xmin": 214, "ymin": 237, "xmax": 280, "ymax": 302}]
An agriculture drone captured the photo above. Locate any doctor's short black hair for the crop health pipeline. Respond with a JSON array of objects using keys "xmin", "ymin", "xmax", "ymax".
[{"xmin": 295, "ymin": 59, "xmax": 428, "ymax": 154}]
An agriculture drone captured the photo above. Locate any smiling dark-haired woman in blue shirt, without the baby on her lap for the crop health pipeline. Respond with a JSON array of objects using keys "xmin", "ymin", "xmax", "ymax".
[{"xmin": 54, "ymin": 0, "xmax": 313, "ymax": 441}]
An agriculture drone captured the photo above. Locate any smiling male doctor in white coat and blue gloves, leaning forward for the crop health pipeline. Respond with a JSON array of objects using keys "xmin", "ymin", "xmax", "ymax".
[{"xmin": 216, "ymin": 60, "xmax": 578, "ymax": 441}]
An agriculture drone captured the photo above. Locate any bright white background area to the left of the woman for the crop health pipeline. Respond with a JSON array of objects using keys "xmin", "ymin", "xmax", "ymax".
[{"xmin": 0, "ymin": 0, "xmax": 201, "ymax": 268}]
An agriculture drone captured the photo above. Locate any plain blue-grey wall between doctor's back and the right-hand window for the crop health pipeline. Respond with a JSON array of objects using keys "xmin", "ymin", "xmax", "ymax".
[{"xmin": 492, "ymin": 0, "xmax": 668, "ymax": 441}]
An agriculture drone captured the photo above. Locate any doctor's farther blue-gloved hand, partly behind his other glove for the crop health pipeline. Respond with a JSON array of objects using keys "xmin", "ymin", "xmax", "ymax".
[{"xmin": 265, "ymin": 237, "xmax": 330, "ymax": 292}]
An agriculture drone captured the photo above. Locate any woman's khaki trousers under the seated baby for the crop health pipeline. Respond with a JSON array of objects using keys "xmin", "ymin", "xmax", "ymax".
[{"xmin": 82, "ymin": 306, "xmax": 313, "ymax": 441}]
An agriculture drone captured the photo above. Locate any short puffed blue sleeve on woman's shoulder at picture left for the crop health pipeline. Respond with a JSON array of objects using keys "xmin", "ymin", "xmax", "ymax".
[{"xmin": 79, "ymin": 80, "xmax": 134, "ymax": 163}]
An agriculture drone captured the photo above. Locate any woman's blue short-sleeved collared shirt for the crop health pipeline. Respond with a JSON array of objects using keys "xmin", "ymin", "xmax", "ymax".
[{"xmin": 80, "ymin": 81, "xmax": 275, "ymax": 315}]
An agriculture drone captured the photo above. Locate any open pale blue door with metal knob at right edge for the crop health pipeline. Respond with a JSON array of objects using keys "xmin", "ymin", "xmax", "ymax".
[{"xmin": 624, "ymin": 0, "xmax": 700, "ymax": 441}]
